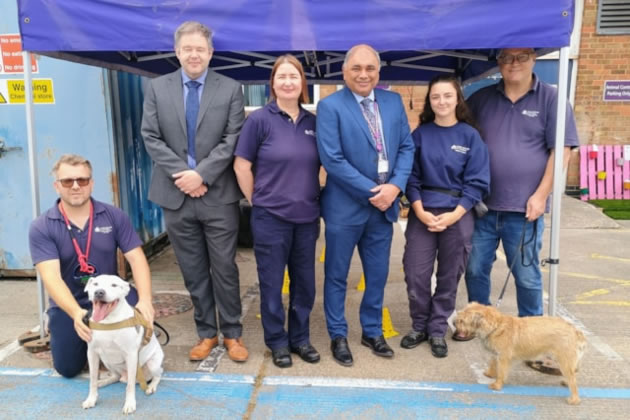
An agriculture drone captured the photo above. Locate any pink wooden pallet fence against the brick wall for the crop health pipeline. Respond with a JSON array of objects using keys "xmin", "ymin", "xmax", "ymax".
[{"xmin": 580, "ymin": 144, "xmax": 630, "ymax": 201}]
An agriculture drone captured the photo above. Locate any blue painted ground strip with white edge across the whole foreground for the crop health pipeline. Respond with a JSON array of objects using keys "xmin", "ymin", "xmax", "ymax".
[{"xmin": 0, "ymin": 368, "xmax": 630, "ymax": 419}]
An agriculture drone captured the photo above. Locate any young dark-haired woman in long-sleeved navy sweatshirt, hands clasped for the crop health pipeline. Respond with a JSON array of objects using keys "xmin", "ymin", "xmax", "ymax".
[{"xmin": 400, "ymin": 75, "xmax": 490, "ymax": 357}]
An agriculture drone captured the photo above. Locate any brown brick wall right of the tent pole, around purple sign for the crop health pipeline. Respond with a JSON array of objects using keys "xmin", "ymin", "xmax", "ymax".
[{"xmin": 567, "ymin": 0, "xmax": 630, "ymax": 186}]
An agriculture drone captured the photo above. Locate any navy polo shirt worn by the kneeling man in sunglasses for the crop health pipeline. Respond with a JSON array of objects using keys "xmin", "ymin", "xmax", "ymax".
[{"xmin": 28, "ymin": 199, "xmax": 142, "ymax": 307}]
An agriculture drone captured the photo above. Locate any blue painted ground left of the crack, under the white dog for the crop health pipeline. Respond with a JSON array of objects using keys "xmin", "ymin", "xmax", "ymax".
[{"xmin": 0, "ymin": 369, "xmax": 254, "ymax": 420}]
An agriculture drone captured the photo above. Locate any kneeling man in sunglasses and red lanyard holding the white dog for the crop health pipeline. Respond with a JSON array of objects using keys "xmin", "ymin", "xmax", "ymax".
[{"xmin": 29, "ymin": 155, "xmax": 154, "ymax": 377}]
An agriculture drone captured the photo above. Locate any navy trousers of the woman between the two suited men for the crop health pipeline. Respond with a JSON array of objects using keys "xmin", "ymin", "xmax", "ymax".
[{"xmin": 251, "ymin": 207, "xmax": 319, "ymax": 350}]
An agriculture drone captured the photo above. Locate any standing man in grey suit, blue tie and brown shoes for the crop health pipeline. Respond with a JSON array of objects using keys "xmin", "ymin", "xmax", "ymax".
[{"xmin": 142, "ymin": 22, "xmax": 248, "ymax": 362}]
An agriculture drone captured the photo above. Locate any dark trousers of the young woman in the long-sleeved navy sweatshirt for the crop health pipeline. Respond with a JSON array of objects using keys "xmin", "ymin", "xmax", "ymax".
[{"xmin": 403, "ymin": 209, "xmax": 475, "ymax": 337}]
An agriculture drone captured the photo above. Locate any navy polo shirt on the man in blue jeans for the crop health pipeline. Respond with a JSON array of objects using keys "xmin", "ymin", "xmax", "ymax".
[{"xmin": 468, "ymin": 74, "xmax": 579, "ymax": 213}]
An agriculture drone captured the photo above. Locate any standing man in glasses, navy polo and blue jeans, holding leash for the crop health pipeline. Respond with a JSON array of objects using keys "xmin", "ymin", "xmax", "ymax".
[{"xmin": 453, "ymin": 48, "xmax": 578, "ymax": 341}]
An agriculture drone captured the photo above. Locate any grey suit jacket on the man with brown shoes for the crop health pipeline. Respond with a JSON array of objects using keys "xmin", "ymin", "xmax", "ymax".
[{"xmin": 141, "ymin": 69, "xmax": 245, "ymax": 210}]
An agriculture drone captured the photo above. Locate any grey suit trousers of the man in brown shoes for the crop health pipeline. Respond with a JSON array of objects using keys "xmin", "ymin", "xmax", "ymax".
[{"xmin": 162, "ymin": 196, "xmax": 243, "ymax": 338}]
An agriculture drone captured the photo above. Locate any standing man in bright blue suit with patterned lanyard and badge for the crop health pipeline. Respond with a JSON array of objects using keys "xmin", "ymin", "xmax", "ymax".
[{"xmin": 317, "ymin": 45, "xmax": 414, "ymax": 366}]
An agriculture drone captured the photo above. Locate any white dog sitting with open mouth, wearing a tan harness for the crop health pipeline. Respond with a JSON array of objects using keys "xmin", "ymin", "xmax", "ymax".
[{"xmin": 83, "ymin": 275, "xmax": 164, "ymax": 414}]
